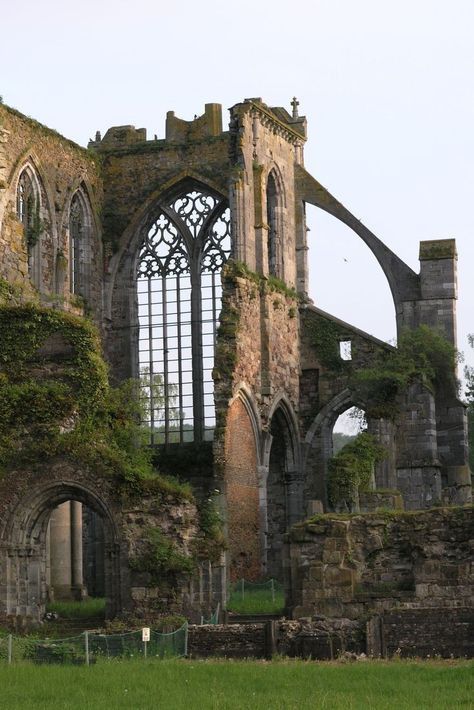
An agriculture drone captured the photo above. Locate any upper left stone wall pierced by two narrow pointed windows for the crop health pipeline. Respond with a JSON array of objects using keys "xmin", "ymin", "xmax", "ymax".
[{"xmin": 0, "ymin": 105, "xmax": 102, "ymax": 321}]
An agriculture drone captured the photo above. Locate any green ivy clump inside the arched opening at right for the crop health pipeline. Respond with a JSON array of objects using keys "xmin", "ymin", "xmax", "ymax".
[{"xmin": 328, "ymin": 432, "xmax": 386, "ymax": 510}]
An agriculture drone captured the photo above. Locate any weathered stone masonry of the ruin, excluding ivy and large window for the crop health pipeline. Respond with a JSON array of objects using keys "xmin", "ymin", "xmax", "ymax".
[{"xmin": 0, "ymin": 98, "xmax": 472, "ymax": 643}]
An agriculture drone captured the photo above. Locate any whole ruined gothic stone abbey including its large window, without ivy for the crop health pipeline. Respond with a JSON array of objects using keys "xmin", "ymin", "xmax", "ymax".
[{"xmin": 0, "ymin": 98, "xmax": 474, "ymax": 652}]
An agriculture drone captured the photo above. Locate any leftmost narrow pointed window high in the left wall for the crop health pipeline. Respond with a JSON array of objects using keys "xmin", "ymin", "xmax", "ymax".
[{"xmin": 16, "ymin": 165, "xmax": 41, "ymax": 287}]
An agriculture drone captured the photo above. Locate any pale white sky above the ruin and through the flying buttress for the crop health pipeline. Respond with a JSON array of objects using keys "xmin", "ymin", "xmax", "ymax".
[{"xmin": 0, "ymin": 0, "xmax": 474, "ymax": 384}]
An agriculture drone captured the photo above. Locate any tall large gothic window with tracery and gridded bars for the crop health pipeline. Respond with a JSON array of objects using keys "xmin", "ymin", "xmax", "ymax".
[{"xmin": 137, "ymin": 185, "xmax": 230, "ymax": 443}]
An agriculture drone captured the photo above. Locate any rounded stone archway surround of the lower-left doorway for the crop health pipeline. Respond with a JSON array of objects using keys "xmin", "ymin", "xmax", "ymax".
[{"xmin": 0, "ymin": 479, "xmax": 122, "ymax": 622}]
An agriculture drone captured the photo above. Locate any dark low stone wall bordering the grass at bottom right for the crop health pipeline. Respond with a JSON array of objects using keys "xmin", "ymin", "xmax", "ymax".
[{"xmin": 367, "ymin": 608, "xmax": 474, "ymax": 658}]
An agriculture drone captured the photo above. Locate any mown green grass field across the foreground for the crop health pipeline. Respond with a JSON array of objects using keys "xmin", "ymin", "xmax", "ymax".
[{"xmin": 0, "ymin": 659, "xmax": 474, "ymax": 710}]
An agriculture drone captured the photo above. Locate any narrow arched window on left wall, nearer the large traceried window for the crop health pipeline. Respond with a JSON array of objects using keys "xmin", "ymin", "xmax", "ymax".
[{"xmin": 69, "ymin": 190, "xmax": 91, "ymax": 297}]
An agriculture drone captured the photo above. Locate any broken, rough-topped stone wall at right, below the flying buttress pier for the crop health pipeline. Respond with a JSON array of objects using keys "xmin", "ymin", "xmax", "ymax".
[{"xmin": 287, "ymin": 507, "xmax": 474, "ymax": 619}]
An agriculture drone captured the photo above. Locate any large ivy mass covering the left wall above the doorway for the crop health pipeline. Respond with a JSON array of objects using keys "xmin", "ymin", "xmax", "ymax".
[{"xmin": 0, "ymin": 304, "xmax": 192, "ymax": 500}]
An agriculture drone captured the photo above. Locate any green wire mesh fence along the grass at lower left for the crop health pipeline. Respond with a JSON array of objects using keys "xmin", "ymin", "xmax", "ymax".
[{"xmin": 0, "ymin": 623, "xmax": 188, "ymax": 665}]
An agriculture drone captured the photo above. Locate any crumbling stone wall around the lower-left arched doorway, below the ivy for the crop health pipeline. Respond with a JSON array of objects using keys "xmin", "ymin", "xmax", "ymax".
[{"xmin": 0, "ymin": 459, "xmax": 203, "ymax": 621}]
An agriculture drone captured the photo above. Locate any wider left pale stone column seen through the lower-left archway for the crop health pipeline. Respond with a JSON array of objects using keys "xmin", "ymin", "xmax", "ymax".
[{"xmin": 49, "ymin": 501, "xmax": 71, "ymax": 599}]
